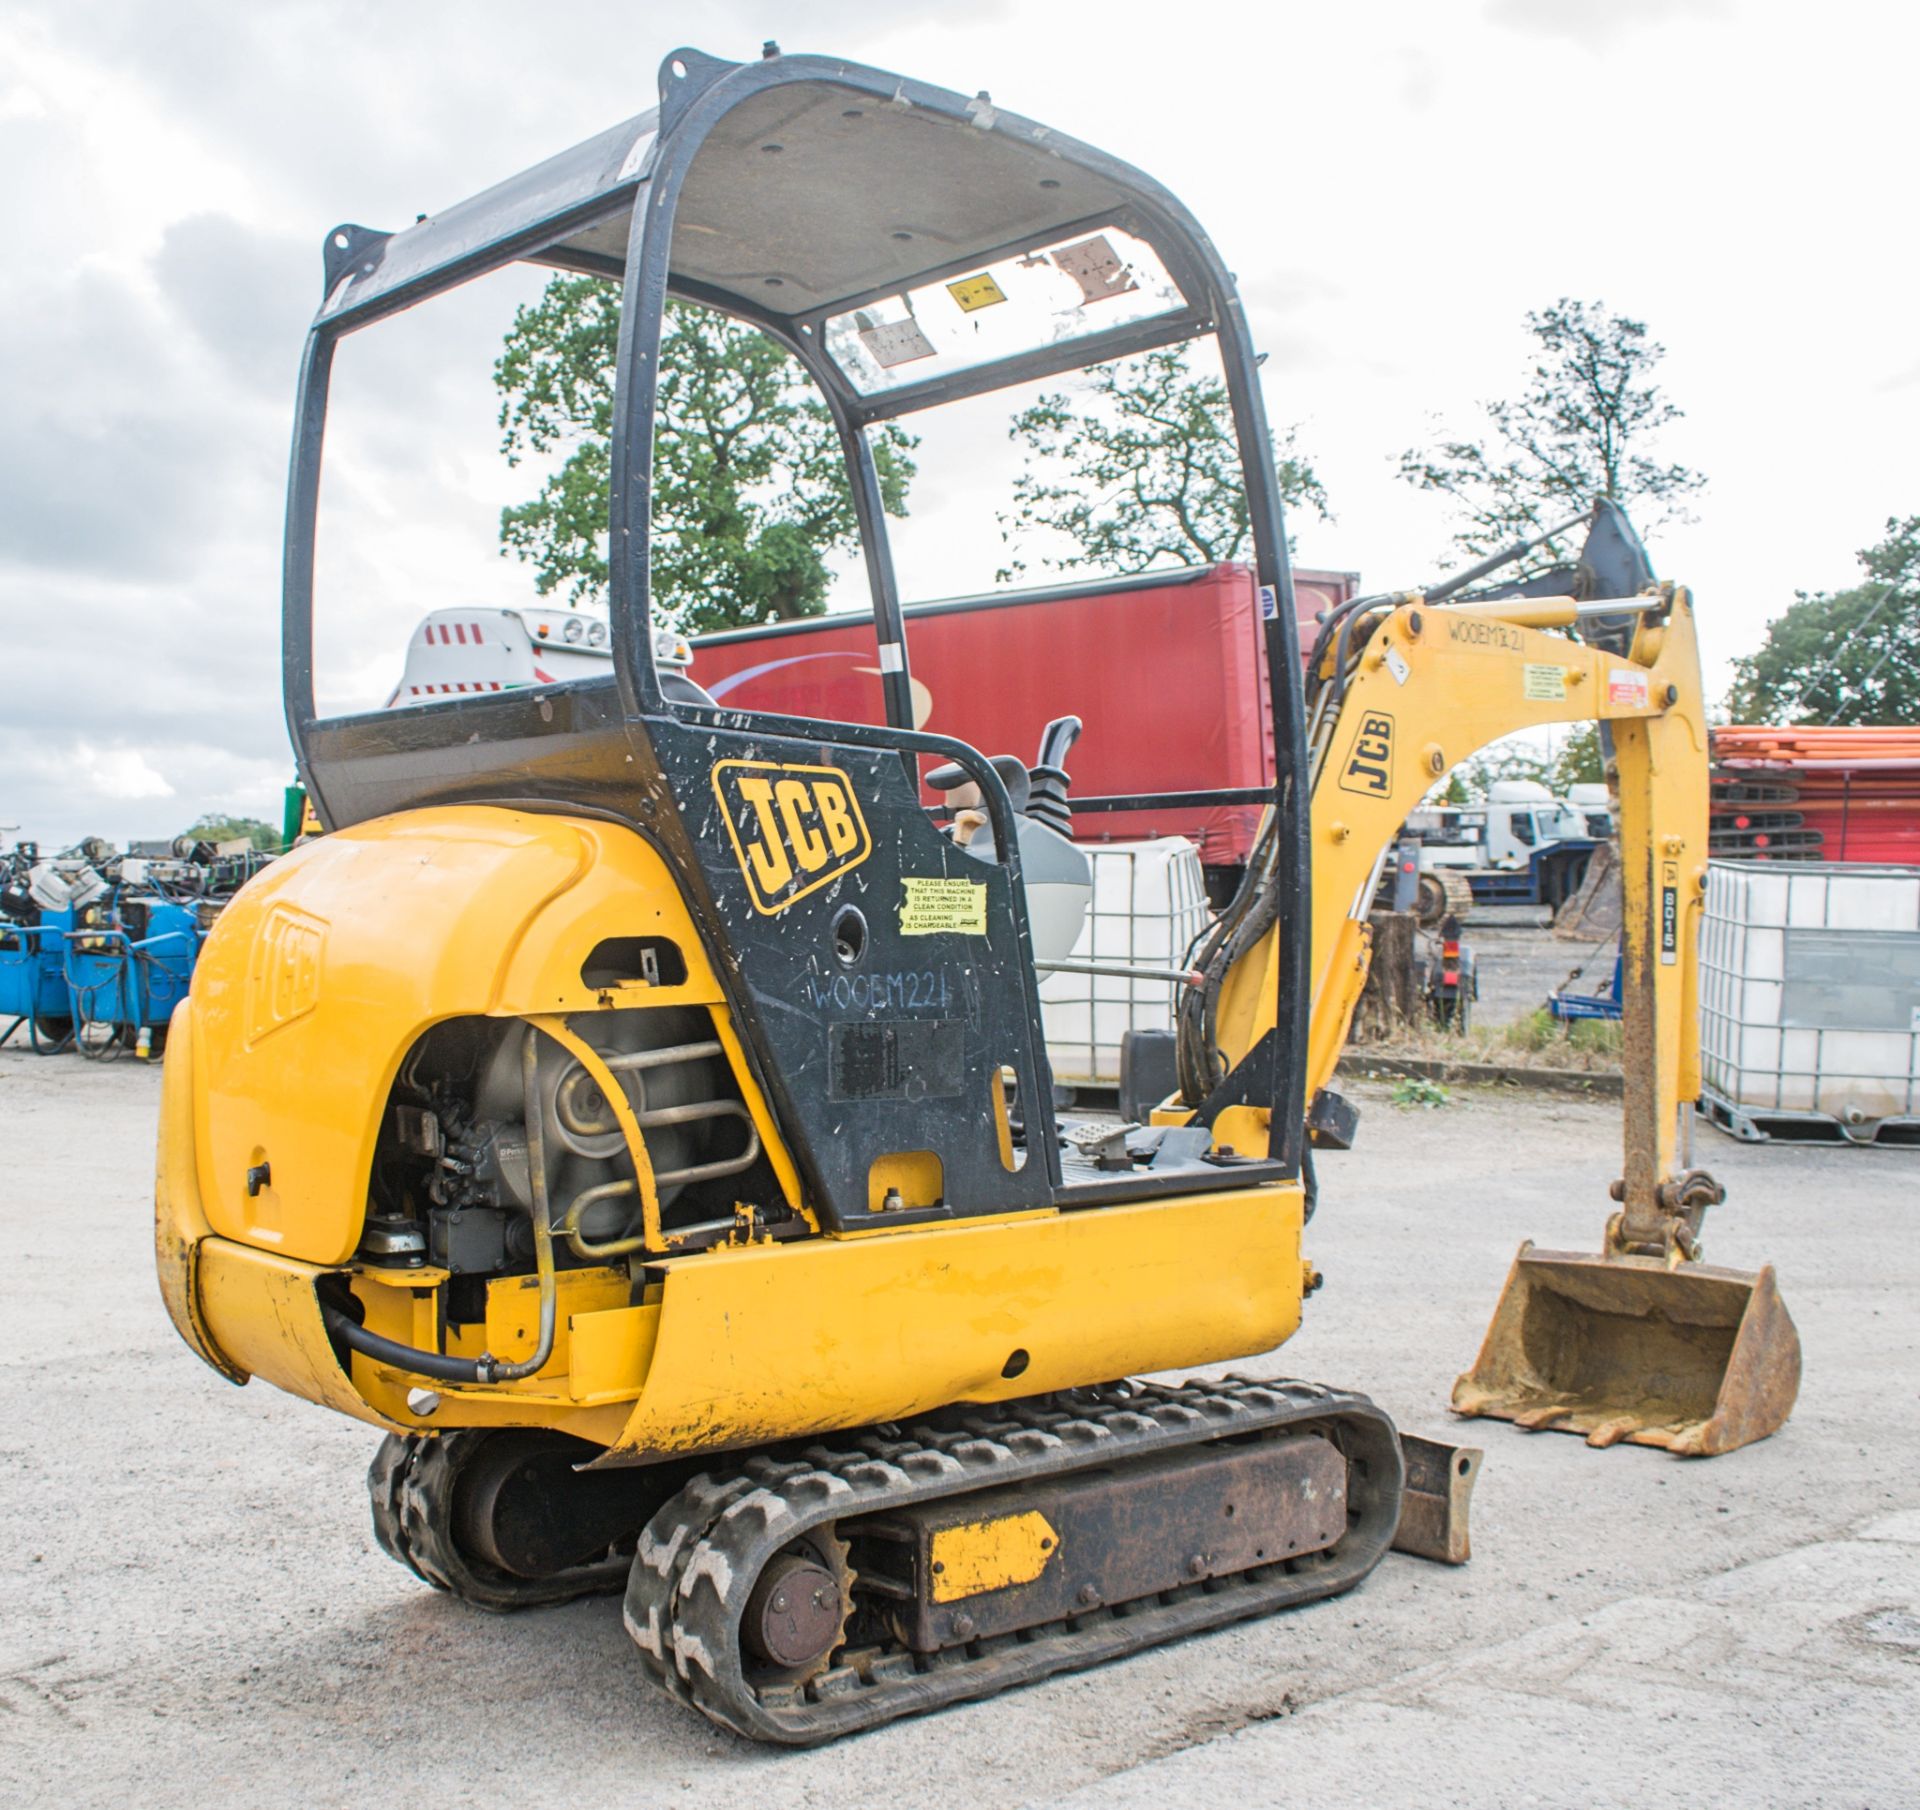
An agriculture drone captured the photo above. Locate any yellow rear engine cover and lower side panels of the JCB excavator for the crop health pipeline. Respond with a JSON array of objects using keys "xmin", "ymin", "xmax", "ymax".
[{"xmin": 157, "ymin": 806, "xmax": 1302, "ymax": 1463}]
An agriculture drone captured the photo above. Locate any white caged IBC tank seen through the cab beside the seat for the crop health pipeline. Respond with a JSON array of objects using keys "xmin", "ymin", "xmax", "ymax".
[{"xmin": 1041, "ymin": 835, "xmax": 1210, "ymax": 1086}]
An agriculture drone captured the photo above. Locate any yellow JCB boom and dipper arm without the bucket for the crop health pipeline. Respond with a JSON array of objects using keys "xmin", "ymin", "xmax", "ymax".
[{"xmin": 1217, "ymin": 589, "xmax": 1707, "ymax": 1246}]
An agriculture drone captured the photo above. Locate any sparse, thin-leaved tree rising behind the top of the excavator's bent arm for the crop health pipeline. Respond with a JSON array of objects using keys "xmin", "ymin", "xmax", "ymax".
[{"xmin": 1400, "ymin": 298, "xmax": 1707, "ymax": 570}]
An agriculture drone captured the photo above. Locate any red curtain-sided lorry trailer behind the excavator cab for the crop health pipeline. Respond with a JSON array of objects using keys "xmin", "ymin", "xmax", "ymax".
[{"xmin": 693, "ymin": 564, "xmax": 1359, "ymax": 885}]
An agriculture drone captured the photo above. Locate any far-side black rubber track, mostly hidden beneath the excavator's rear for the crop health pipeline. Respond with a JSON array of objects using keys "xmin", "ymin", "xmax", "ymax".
[{"xmin": 367, "ymin": 1430, "xmax": 628, "ymax": 1614}]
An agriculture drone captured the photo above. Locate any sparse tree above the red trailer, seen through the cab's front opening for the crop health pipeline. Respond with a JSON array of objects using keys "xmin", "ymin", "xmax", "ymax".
[{"xmin": 998, "ymin": 345, "xmax": 1327, "ymax": 580}]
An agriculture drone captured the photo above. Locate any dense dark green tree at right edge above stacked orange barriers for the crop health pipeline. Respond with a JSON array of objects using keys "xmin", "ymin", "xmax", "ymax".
[{"xmin": 1726, "ymin": 516, "xmax": 1920, "ymax": 724}]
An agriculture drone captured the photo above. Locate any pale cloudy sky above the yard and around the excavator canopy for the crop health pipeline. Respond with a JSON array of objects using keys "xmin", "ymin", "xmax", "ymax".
[{"xmin": 0, "ymin": 0, "xmax": 1920, "ymax": 845}]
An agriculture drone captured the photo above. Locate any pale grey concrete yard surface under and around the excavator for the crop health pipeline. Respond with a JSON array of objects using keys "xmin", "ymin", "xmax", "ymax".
[{"xmin": 0, "ymin": 1048, "xmax": 1920, "ymax": 1810}]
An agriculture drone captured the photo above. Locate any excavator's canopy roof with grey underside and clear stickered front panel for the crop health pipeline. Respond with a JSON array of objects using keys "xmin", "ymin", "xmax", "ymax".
[{"xmin": 315, "ymin": 52, "xmax": 1212, "ymax": 417}]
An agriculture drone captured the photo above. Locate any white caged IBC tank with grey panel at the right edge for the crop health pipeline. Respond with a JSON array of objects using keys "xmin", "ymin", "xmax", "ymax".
[{"xmin": 1699, "ymin": 862, "xmax": 1920, "ymax": 1127}]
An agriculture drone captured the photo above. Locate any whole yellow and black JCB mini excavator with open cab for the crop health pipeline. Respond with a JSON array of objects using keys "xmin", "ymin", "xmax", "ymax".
[{"xmin": 157, "ymin": 52, "xmax": 1797, "ymax": 1743}]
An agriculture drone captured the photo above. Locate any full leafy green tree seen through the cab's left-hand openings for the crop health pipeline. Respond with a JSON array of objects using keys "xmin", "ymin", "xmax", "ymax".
[{"xmin": 493, "ymin": 276, "xmax": 916, "ymax": 631}]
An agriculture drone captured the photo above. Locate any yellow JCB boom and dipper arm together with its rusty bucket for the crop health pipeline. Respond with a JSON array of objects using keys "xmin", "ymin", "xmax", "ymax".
[{"xmin": 1215, "ymin": 587, "xmax": 1799, "ymax": 1457}]
